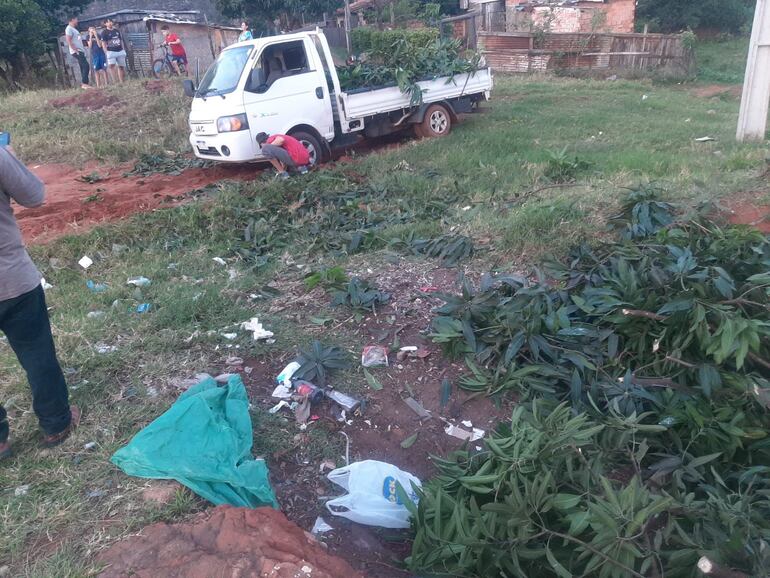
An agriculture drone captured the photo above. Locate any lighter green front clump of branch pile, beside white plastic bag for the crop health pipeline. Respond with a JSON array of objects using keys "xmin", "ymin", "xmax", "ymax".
[{"xmin": 404, "ymin": 401, "xmax": 770, "ymax": 578}]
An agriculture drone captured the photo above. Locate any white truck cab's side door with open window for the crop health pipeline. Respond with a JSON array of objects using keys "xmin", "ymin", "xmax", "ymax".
[{"xmin": 244, "ymin": 38, "xmax": 334, "ymax": 148}]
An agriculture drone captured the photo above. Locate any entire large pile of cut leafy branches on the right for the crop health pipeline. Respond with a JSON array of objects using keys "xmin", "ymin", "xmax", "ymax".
[{"xmin": 405, "ymin": 191, "xmax": 770, "ymax": 578}]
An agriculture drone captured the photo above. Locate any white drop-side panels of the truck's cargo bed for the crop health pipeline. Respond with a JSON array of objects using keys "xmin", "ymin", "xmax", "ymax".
[{"xmin": 340, "ymin": 68, "xmax": 492, "ymax": 120}]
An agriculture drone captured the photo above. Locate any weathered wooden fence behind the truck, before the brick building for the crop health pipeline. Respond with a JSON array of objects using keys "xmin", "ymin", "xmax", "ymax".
[{"xmin": 478, "ymin": 32, "xmax": 695, "ymax": 76}]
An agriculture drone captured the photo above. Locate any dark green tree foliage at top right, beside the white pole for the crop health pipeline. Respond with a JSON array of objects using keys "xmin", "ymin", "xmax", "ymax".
[{"xmin": 636, "ymin": 0, "xmax": 755, "ymax": 33}]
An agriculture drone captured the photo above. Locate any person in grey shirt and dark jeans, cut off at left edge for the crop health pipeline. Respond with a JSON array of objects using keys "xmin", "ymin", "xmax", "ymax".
[{"xmin": 0, "ymin": 147, "xmax": 80, "ymax": 461}]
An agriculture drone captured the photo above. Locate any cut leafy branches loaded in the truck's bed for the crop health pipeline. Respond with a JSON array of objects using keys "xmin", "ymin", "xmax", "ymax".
[{"xmin": 338, "ymin": 28, "xmax": 481, "ymax": 104}]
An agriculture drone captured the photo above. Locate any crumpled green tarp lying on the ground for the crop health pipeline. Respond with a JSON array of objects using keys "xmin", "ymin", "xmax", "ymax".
[{"xmin": 112, "ymin": 376, "xmax": 278, "ymax": 508}]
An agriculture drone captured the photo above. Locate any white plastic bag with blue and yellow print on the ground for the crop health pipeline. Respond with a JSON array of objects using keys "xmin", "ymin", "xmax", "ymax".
[{"xmin": 326, "ymin": 460, "xmax": 422, "ymax": 528}]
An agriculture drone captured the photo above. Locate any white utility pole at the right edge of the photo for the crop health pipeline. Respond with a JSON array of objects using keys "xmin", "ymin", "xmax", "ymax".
[{"xmin": 737, "ymin": 0, "xmax": 770, "ymax": 142}]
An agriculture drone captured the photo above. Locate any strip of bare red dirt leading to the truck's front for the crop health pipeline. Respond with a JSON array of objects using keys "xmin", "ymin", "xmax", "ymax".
[{"xmin": 16, "ymin": 164, "xmax": 260, "ymax": 243}]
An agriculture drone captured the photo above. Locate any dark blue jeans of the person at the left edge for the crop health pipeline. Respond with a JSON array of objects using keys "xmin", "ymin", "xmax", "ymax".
[{"xmin": 0, "ymin": 286, "xmax": 72, "ymax": 443}]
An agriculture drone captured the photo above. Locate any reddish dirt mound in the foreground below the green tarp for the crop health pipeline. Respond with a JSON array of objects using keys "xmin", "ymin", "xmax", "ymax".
[{"xmin": 99, "ymin": 506, "xmax": 363, "ymax": 578}]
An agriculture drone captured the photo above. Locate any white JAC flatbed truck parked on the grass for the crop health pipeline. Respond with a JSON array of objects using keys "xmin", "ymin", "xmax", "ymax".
[{"xmin": 185, "ymin": 30, "xmax": 492, "ymax": 163}]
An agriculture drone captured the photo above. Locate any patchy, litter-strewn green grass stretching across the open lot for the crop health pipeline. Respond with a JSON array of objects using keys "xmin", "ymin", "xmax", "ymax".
[{"xmin": 0, "ymin": 66, "xmax": 768, "ymax": 577}]
